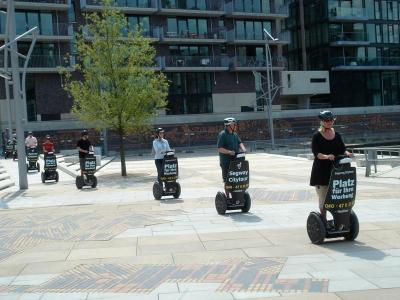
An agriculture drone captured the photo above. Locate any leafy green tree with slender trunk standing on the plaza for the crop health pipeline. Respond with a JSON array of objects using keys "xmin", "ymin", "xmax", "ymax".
[{"xmin": 61, "ymin": 0, "xmax": 168, "ymax": 176}]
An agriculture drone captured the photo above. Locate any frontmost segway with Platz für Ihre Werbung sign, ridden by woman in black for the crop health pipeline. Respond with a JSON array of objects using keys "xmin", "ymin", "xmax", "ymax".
[{"xmin": 307, "ymin": 156, "xmax": 359, "ymax": 244}]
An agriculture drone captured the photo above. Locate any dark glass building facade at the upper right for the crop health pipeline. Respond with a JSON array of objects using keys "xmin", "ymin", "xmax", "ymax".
[{"xmin": 285, "ymin": 0, "xmax": 400, "ymax": 107}]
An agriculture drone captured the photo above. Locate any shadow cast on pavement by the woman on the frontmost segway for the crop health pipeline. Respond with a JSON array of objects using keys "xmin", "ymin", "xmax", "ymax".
[{"xmin": 321, "ymin": 239, "xmax": 387, "ymax": 260}]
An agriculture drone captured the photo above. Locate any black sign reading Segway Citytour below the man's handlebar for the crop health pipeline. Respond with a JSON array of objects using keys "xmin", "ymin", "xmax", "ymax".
[{"xmin": 225, "ymin": 160, "xmax": 250, "ymax": 191}]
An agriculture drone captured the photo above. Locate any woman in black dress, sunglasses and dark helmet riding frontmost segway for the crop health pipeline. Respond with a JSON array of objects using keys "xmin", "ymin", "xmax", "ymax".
[{"xmin": 310, "ymin": 110, "xmax": 352, "ymax": 220}]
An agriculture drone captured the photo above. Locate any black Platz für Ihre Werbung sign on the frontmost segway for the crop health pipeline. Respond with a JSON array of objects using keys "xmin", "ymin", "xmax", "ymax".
[{"xmin": 324, "ymin": 167, "xmax": 357, "ymax": 210}]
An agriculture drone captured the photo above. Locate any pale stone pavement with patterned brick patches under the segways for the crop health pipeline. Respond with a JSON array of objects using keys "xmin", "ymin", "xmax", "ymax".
[{"xmin": 0, "ymin": 153, "xmax": 400, "ymax": 300}]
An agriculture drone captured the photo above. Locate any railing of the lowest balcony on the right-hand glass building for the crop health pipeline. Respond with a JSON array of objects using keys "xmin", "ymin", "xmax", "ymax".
[{"xmin": 331, "ymin": 57, "xmax": 400, "ymax": 67}]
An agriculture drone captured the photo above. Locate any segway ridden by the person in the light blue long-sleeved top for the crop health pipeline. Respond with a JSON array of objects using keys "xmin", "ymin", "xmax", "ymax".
[{"xmin": 153, "ymin": 151, "xmax": 181, "ymax": 200}]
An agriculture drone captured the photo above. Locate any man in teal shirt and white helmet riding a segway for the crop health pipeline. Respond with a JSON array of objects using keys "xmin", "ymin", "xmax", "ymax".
[{"xmin": 217, "ymin": 117, "xmax": 246, "ymax": 197}]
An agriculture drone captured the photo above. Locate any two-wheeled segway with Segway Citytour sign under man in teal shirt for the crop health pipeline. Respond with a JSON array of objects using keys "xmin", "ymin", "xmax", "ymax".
[{"xmin": 215, "ymin": 153, "xmax": 251, "ymax": 215}]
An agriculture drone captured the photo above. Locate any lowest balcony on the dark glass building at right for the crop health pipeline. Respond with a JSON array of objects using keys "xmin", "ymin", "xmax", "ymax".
[{"xmin": 330, "ymin": 57, "xmax": 400, "ymax": 71}]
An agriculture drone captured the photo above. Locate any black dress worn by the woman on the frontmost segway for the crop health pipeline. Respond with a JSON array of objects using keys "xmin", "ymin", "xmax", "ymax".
[{"xmin": 310, "ymin": 131, "xmax": 346, "ymax": 186}]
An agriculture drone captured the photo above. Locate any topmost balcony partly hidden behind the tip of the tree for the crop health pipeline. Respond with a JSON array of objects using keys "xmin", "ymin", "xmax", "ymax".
[{"xmin": 80, "ymin": 0, "xmax": 158, "ymax": 15}]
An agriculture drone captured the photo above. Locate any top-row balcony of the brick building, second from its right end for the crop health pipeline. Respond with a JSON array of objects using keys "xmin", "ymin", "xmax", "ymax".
[{"xmin": 159, "ymin": 0, "xmax": 225, "ymax": 17}]
